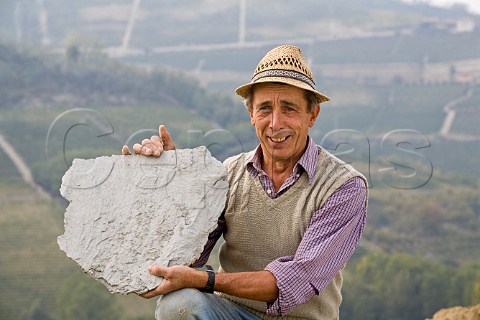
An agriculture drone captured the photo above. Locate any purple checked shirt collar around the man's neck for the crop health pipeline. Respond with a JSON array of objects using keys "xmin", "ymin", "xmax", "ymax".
[{"xmin": 247, "ymin": 136, "xmax": 320, "ymax": 181}]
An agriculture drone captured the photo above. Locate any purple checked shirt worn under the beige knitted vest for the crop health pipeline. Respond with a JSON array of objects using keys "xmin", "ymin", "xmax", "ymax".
[{"xmin": 192, "ymin": 138, "xmax": 367, "ymax": 315}]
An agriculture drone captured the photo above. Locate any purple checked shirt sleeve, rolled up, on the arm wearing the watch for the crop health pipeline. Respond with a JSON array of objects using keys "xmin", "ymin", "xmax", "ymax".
[{"xmin": 265, "ymin": 177, "xmax": 367, "ymax": 315}]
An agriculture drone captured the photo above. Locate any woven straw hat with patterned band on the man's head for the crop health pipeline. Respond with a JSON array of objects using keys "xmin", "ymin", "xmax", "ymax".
[{"xmin": 235, "ymin": 45, "xmax": 330, "ymax": 102}]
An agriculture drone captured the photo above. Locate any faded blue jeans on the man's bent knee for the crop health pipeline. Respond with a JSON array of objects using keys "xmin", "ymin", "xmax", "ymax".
[{"xmin": 155, "ymin": 289, "xmax": 260, "ymax": 320}]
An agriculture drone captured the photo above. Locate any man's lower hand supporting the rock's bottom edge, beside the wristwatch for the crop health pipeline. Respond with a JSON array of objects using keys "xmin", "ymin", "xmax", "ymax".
[{"xmin": 140, "ymin": 265, "xmax": 208, "ymax": 299}]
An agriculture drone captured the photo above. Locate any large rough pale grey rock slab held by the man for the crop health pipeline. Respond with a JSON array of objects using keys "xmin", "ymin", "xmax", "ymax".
[{"xmin": 57, "ymin": 147, "xmax": 228, "ymax": 294}]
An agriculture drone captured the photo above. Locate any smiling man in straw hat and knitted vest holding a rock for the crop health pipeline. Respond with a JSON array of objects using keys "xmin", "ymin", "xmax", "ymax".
[{"xmin": 122, "ymin": 46, "xmax": 367, "ymax": 320}]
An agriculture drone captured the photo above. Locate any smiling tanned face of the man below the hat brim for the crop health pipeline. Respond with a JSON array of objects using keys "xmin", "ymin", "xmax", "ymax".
[{"xmin": 250, "ymin": 83, "xmax": 320, "ymax": 165}]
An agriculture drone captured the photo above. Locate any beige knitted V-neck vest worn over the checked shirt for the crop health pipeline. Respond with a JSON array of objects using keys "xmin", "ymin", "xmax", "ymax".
[{"xmin": 220, "ymin": 149, "xmax": 366, "ymax": 320}]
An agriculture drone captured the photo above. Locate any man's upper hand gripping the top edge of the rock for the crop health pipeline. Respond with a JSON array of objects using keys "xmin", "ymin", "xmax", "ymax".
[{"xmin": 122, "ymin": 125, "xmax": 175, "ymax": 157}]
